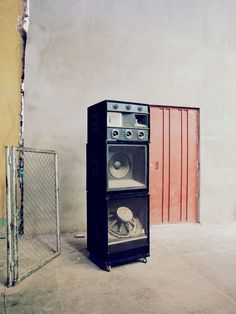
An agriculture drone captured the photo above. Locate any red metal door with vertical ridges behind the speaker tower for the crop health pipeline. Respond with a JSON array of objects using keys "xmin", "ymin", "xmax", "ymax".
[{"xmin": 150, "ymin": 106, "xmax": 199, "ymax": 224}]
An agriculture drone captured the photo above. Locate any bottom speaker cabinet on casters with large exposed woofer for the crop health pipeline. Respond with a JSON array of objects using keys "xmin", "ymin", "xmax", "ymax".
[{"xmin": 87, "ymin": 193, "xmax": 149, "ymax": 270}]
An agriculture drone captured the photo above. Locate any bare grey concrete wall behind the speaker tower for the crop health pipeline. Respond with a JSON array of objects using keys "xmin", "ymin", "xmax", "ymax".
[{"xmin": 25, "ymin": 0, "xmax": 236, "ymax": 231}]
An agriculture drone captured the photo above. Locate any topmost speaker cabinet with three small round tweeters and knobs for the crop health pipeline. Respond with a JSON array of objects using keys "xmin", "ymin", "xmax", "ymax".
[{"xmin": 88, "ymin": 100, "xmax": 150, "ymax": 145}]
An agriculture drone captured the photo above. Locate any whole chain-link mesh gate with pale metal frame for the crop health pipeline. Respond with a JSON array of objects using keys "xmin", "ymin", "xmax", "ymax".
[{"xmin": 7, "ymin": 148, "xmax": 60, "ymax": 286}]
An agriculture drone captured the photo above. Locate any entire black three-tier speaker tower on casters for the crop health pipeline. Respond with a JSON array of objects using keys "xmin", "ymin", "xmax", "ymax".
[{"xmin": 87, "ymin": 100, "xmax": 150, "ymax": 270}]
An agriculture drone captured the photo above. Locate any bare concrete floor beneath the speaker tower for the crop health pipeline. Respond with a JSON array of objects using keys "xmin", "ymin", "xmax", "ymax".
[{"xmin": 0, "ymin": 224, "xmax": 236, "ymax": 314}]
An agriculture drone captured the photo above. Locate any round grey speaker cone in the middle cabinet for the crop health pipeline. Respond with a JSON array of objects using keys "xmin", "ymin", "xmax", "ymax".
[{"xmin": 108, "ymin": 153, "xmax": 131, "ymax": 179}]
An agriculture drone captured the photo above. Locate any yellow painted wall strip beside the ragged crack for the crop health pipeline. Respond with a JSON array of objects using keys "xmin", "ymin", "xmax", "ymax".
[{"xmin": 0, "ymin": 0, "xmax": 23, "ymax": 228}]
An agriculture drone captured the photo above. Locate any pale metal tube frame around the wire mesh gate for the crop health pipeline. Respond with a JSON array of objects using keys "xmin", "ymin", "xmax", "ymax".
[{"xmin": 6, "ymin": 146, "xmax": 61, "ymax": 287}]
